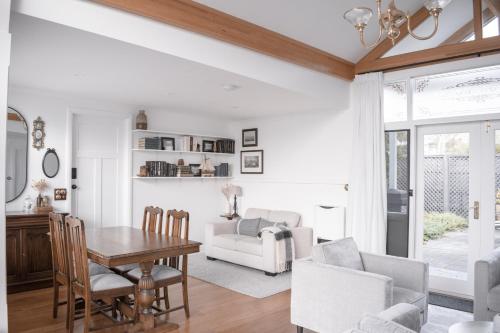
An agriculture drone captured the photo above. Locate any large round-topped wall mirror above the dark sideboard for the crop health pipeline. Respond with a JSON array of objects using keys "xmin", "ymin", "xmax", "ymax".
[{"xmin": 5, "ymin": 107, "xmax": 28, "ymax": 202}]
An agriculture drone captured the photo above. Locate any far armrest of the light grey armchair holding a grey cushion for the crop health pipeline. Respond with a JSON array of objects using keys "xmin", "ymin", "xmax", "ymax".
[{"xmin": 361, "ymin": 252, "xmax": 429, "ymax": 295}]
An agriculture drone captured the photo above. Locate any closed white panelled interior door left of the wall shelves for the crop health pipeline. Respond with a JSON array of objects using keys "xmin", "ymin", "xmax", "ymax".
[{"xmin": 72, "ymin": 114, "xmax": 128, "ymax": 227}]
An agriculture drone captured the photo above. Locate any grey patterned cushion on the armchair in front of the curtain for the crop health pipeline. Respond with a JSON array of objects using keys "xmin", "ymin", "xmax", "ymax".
[{"xmin": 312, "ymin": 238, "xmax": 365, "ymax": 271}]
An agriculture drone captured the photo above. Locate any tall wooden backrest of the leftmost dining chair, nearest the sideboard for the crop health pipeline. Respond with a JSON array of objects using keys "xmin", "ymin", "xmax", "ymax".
[{"xmin": 49, "ymin": 213, "xmax": 69, "ymax": 278}]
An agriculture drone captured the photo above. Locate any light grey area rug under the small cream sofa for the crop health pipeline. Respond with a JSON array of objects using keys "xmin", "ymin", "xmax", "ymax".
[{"xmin": 188, "ymin": 253, "xmax": 291, "ymax": 298}]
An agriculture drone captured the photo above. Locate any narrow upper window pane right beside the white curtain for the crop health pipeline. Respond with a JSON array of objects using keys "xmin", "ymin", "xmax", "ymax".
[{"xmin": 384, "ymin": 81, "xmax": 407, "ymax": 123}]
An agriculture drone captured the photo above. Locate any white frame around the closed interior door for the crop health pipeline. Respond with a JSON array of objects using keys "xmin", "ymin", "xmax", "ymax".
[{"xmin": 66, "ymin": 107, "xmax": 133, "ymax": 226}]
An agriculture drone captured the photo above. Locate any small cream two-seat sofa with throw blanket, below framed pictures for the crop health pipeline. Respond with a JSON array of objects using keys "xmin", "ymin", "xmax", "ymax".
[{"xmin": 205, "ymin": 208, "xmax": 313, "ymax": 276}]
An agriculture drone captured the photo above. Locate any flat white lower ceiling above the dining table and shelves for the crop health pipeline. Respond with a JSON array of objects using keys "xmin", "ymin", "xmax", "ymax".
[{"xmin": 9, "ymin": 14, "xmax": 332, "ymax": 119}]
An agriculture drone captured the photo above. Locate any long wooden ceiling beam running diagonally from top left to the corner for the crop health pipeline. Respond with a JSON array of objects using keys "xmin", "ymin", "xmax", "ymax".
[{"xmin": 92, "ymin": 0, "xmax": 354, "ymax": 80}]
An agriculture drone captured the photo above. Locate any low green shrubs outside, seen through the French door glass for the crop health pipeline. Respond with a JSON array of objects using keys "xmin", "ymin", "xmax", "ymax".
[{"xmin": 424, "ymin": 213, "xmax": 469, "ymax": 242}]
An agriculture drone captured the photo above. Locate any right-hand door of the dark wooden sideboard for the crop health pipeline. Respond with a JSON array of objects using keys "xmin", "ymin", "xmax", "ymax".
[{"xmin": 23, "ymin": 227, "xmax": 52, "ymax": 281}]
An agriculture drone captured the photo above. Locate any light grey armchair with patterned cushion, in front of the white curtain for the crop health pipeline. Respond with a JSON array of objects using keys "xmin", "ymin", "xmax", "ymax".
[{"xmin": 291, "ymin": 240, "xmax": 429, "ymax": 333}]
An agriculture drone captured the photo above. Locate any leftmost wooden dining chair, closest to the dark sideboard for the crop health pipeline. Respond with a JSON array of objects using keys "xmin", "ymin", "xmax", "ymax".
[{"xmin": 49, "ymin": 212, "xmax": 112, "ymax": 328}]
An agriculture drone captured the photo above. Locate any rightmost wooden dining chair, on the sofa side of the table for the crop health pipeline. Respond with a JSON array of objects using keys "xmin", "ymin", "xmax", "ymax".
[{"xmin": 127, "ymin": 210, "xmax": 189, "ymax": 318}]
